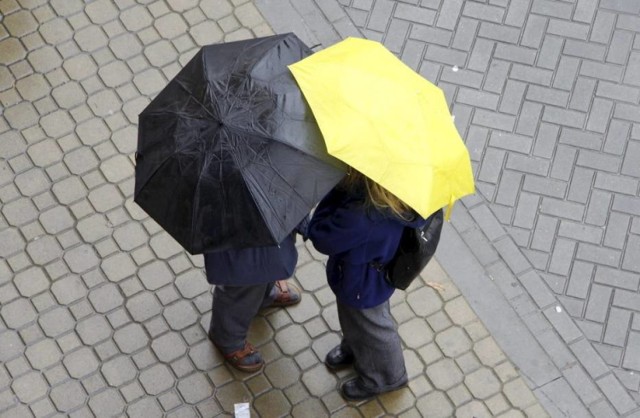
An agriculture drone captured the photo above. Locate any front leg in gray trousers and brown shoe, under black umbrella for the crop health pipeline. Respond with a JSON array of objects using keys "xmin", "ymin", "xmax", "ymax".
[{"xmin": 209, "ymin": 283, "xmax": 273, "ymax": 371}]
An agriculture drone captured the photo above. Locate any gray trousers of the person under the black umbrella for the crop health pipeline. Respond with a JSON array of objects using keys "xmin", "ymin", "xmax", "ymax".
[{"xmin": 209, "ymin": 282, "xmax": 274, "ymax": 354}]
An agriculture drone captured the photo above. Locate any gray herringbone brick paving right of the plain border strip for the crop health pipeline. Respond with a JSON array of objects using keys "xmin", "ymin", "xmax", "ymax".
[{"xmin": 341, "ymin": 0, "xmax": 640, "ymax": 399}]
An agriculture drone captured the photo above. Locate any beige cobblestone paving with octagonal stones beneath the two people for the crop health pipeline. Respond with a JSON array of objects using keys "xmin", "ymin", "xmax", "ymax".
[{"xmin": 0, "ymin": 0, "xmax": 547, "ymax": 418}]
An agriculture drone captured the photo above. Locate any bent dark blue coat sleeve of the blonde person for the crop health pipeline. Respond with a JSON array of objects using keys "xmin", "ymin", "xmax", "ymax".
[{"xmin": 309, "ymin": 191, "xmax": 370, "ymax": 255}]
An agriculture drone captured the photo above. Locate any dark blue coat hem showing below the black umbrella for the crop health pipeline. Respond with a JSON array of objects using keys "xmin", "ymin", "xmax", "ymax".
[{"xmin": 204, "ymin": 234, "xmax": 298, "ymax": 286}]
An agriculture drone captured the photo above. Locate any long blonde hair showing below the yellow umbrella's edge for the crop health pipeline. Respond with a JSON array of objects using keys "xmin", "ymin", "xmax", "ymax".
[{"xmin": 340, "ymin": 168, "xmax": 413, "ymax": 220}]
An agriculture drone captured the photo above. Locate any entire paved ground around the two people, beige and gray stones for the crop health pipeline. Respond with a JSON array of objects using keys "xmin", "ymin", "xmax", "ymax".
[{"xmin": 0, "ymin": 0, "xmax": 640, "ymax": 418}]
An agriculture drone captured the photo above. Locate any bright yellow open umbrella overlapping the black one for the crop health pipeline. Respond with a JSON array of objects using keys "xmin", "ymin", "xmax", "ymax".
[{"xmin": 289, "ymin": 38, "xmax": 474, "ymax": 218}]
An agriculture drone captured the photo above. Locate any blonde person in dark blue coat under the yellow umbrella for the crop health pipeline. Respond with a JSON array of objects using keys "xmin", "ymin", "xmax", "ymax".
[{"xmin": 308, "ymin": 169, "xmax": 426, "ymax": 400}]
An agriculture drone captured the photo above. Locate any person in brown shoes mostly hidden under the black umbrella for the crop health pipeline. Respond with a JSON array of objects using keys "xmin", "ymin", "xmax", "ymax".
[{"xmin": 204, "ymin": 225, "xmax": 307, "ymax": 372}]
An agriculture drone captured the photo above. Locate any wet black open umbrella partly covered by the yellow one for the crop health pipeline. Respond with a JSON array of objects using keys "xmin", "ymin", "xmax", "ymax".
[{"xmin": 134, "ymin": 34, "xmax": 344, "ymax": 254}]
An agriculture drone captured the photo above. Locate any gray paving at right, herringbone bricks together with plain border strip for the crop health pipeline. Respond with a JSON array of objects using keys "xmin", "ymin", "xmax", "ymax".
[{"xmin": 256, "ymin": 0, "xmax": 640, "ymax": 416}]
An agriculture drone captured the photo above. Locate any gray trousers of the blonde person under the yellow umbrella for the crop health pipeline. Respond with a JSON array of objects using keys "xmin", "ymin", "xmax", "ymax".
[{"xmin": 338, "ymin": 300, "xmax": 407, "ymax": 393}]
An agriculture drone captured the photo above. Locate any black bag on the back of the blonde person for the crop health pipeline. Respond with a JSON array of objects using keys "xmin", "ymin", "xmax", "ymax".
[{"xmin": 374, "ymin": 209, "xmax": 444, "ymax": 290}]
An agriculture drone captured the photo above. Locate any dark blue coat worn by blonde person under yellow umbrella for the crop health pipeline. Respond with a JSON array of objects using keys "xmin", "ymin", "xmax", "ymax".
[{"xmin": 308, "ymin": 188, "xmax": 426, "ymax": 309}]
